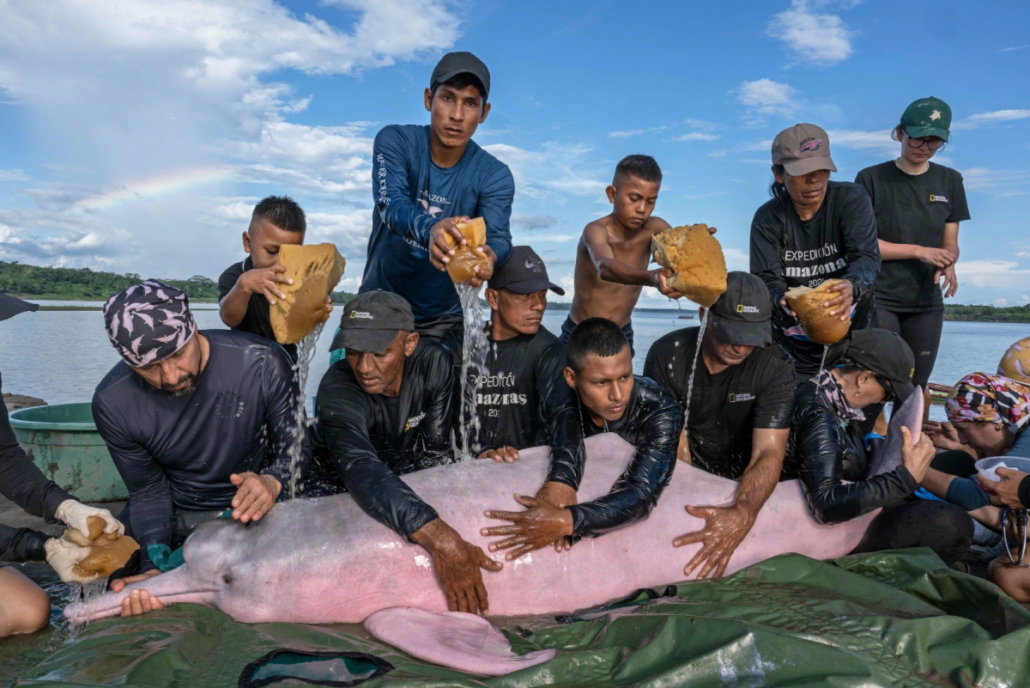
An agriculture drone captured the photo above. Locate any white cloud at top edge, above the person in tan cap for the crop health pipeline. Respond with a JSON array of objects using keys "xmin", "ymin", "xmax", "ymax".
[{"xmin": 767, "ymin": 0, "xmax": 856, "ymax": 65}]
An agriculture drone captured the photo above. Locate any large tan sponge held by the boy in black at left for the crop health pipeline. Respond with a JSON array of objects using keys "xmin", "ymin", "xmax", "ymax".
[{"xmin": 269, "ymin": 244, "xmax": 347, "ymax": 344}]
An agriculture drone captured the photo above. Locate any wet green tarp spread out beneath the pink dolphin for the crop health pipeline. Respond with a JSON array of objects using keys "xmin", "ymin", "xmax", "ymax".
[{"xmin": 15, "ymin": 549, "xmax": 1030, "ymax": 688}]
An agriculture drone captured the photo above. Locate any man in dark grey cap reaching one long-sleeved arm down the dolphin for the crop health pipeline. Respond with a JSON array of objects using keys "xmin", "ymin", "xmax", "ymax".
[{"xmin": 317, "ymin": 289, "xmax": 503, "ymax": 614}]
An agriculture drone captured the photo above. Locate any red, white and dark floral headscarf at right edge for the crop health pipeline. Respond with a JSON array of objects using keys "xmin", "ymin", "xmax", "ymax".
[{"xmin": 945, "ymin": 373, "xmax": 1030, "ymax": 435}]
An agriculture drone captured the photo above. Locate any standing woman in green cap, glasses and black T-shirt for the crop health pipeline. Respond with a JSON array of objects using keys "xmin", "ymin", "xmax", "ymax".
[{"xmin": 855, "ymin": 98, "xmax": 969, "ymax": 397}]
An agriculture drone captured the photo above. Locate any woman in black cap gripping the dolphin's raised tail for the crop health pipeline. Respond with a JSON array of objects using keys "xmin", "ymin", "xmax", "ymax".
[{"xmin": 785, "ymin": 329, "xmax": 973, "ymax": 563}]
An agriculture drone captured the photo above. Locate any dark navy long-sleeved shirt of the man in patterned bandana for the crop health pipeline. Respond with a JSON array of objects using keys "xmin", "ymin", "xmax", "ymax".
[{"xmin": 93, "ymin": 330, "xmax": 303, "ymax": 571}]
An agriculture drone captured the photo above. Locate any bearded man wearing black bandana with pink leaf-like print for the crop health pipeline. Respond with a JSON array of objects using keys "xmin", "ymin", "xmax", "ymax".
[{"xmin": 93, "ymin": 280, "xmax": 303, "ymax": 613}]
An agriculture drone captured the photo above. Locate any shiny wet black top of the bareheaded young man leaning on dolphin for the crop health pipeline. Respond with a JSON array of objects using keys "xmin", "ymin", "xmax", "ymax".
[{"xmin": 547, "ymin": 377, "xmax": 683, "ymax": 538}]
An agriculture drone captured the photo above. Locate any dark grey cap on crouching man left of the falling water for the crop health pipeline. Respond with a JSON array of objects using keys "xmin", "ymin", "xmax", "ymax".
[{"xmin": 329, "ymin": 289, "xmax": 415, "ymax": 353}]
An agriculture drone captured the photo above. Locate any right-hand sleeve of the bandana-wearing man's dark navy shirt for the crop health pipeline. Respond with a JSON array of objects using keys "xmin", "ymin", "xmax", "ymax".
[{"xmin": 262, "ymin": 346, "xmax": 310, "ymax": 487}]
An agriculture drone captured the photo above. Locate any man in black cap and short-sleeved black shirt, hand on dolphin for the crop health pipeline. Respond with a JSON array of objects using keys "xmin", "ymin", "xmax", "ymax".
[{"xmin": 644, "ymin": 272, "xmax": 795, "ymax": 578}]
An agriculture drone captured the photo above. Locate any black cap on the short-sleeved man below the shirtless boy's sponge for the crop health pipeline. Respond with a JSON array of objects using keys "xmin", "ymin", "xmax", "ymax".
[{"xmin": 709, "ymin": 272, "xmax": 773, "ymax": 346}]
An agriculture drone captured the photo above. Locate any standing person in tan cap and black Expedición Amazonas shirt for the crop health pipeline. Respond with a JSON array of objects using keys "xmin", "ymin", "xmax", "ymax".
[{"xmin": 751, "ymin": 125, "xmax": 880, "ymax": 380}]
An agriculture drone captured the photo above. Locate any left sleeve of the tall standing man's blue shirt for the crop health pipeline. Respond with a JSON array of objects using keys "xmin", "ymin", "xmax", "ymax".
[{"xmin": 372, "ymin": 127, "xmax": 438, "ymax": 246}]
